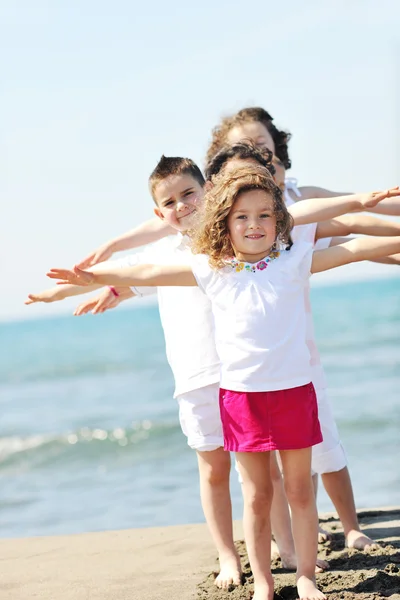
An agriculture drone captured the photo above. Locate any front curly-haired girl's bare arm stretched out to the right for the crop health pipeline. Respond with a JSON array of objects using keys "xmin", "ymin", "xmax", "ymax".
[{"xmin": 311, "ymin": 236, "xmax": 400, "ymax": 273}]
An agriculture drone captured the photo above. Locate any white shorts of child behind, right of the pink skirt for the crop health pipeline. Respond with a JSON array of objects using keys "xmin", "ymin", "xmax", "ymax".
[{"xmin": 311, "ymin": 388, "xmax": 347, "ymax": 475}]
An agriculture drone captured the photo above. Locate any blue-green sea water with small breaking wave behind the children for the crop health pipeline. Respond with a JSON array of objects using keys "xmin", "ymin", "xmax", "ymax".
[{"xmin": 0, "ymin": 278, "xmax": 400, "ymax": 538}]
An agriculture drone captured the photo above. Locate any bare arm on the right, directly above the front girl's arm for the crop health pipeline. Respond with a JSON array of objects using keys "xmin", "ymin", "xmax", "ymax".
[{"xmin": 315, "ymin": 213, "xmax": 400, "ymax": 240}]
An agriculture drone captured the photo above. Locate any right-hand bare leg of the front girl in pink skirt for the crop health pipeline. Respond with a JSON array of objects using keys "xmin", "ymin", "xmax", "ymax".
[{"xmin": 280, "ymin": 448, "xmax": 325, "ymax": 600}]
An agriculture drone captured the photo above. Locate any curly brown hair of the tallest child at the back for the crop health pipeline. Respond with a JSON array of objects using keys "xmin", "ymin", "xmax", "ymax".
[{"xmin": 206, "ymin": 106, "xmax": 292, "ymax": 169}]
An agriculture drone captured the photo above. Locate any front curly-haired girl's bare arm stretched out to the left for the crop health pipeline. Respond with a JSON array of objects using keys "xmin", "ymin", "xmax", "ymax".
[{"xmin": 47, "ymin": 263, "xmax": 197, "ymax": 287}]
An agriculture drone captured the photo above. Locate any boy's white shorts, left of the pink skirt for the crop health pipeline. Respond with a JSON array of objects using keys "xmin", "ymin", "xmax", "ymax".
[{"xmin": 176, "ymin": 383, "xmax": 224, "ymax": 452}]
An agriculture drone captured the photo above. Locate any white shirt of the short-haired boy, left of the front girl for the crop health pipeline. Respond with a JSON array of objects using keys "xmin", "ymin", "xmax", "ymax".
[{"xmin": 118, "ymin": 234, "xmax": 219, "ymax": 397}]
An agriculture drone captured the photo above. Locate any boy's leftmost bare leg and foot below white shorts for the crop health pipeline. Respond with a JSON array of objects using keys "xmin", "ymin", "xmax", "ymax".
[{"xmin": 197, "ymin": 448, "xmax": 241, "ymax": 588}]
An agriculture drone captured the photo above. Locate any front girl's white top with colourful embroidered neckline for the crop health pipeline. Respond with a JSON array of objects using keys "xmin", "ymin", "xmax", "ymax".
[{"xmin": 192, "ymin": 242, "xmax": 313, "ymax": 392}]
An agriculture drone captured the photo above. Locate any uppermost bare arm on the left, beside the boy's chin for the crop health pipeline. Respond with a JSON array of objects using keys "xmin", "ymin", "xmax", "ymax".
[{"xmin": 78, "ymin": 218, "xmax": 176, "ymax": 269}]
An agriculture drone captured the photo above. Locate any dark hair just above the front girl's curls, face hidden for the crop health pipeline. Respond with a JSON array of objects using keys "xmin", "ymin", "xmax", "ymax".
[{"xmin": 204, "ymin": 140, "xmax": 275, "ymax": 180}]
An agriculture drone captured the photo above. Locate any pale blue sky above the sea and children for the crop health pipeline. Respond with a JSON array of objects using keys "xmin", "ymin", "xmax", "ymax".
[{"xmin": 0, "ymin": 0, "xmax": 400, "ymax": 320}]
